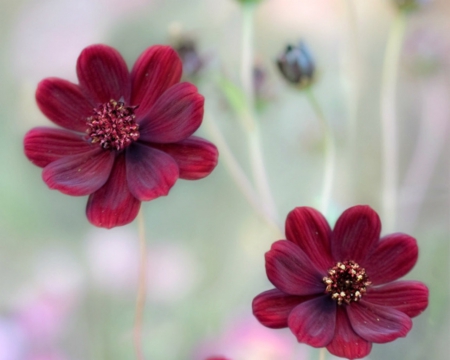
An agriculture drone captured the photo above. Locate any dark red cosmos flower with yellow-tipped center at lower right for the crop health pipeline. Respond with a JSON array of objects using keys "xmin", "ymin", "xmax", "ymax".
[{"xmin": 253, "ymin": 206, "xmax": 428, "ymax": 359}]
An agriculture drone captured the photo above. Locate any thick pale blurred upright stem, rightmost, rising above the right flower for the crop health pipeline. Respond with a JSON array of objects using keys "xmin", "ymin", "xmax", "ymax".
[{"xmin": 381, "ymin": 12, "xmax": 406, "ymax": 232}]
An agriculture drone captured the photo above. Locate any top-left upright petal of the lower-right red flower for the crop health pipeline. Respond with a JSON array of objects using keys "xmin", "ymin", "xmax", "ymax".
[{"xmin": 286, "ymin": 207, "xmax": 334, "ymax": 272}]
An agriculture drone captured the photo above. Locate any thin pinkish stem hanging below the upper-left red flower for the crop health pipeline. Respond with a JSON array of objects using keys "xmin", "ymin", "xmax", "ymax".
[{"xmin": 133, "ymin": 207, "xmax": 147, "ymax": 360}]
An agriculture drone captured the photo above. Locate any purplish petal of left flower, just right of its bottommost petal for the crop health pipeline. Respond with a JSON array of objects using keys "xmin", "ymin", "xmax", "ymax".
[{"xmin": 126, "ymin": 143, "xmax": 178, "ymax": 201}]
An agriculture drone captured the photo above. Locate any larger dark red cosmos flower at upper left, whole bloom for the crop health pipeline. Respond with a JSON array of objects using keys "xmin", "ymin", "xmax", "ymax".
[{"xmin": 24, "ymin": 45, "xmax": 218, "ymax": 228}]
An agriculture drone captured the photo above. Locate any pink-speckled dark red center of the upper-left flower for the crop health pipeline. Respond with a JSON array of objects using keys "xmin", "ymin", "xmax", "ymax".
[{"xmin": 86, "ymin": 100, "xmax": 139, "ymax": 150}]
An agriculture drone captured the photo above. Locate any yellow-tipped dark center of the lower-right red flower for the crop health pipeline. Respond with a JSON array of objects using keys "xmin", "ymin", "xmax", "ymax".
[{"xmin": 323, "ymin": 261, "xmax": 371, "ymax": 305}]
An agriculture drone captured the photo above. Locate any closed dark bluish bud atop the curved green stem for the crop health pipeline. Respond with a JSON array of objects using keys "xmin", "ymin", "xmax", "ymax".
[{"xmin": 277, "ymin": 41, "xmax": 316, "ymax": 89}]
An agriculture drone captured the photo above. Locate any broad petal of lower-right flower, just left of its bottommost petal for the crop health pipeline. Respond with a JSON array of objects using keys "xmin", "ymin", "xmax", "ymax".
[{"xmin": 288, "ymin": 296, "xmax": 337, "ymax": 347}]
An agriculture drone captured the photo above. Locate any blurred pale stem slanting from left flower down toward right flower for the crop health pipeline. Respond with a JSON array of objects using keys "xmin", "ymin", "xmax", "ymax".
[{"xmin": 204, "ymin": 114, "xmax": 281, "ymax": 232}]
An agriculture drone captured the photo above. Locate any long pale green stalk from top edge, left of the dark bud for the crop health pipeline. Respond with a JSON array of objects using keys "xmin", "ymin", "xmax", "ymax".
[{"xmin": 241, "ymin": 3, "xmax": 277, "ymax": 222}]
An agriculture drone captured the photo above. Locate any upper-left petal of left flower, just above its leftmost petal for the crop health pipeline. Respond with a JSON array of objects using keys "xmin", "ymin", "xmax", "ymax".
[{"xmin": 36, "ymin": 78, "xmax": 95, "ymax": 133}]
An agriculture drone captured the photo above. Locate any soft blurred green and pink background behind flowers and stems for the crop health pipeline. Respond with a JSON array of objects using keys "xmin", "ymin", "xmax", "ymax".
[{"xmin": 0, "ymin": 0, "xmax": 450, "ymax": 360}]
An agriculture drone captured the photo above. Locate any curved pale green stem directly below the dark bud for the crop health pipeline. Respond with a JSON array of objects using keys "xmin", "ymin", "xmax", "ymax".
[{"xmin": 305, "ymin": 88, "xmax": 336, "ymax": 217}]
